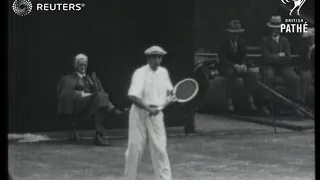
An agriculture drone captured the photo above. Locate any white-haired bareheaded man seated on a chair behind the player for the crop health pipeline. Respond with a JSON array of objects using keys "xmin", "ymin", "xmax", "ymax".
[{"xmin": 57, "ymin": 54, "xmax": 121, "ymax": 146}]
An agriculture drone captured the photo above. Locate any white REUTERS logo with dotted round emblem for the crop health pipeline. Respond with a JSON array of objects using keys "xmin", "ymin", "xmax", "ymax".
[{"xmin": 12, "ymin": 0, "xmax": 85, "ymax": 16}]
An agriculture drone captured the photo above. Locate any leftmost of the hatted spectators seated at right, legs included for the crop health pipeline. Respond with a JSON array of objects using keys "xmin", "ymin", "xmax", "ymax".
[{"xmin": 219, "ymin": 20, "xmax": 270, "ymax": 114}]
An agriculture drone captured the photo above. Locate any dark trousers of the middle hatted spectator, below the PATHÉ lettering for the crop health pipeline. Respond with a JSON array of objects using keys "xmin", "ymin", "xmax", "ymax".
[{"xmin": 261, "ymin": 66, "xmax": 302, "ymax": 102}]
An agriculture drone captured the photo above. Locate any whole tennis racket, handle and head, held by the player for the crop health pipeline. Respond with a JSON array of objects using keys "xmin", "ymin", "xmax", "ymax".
[{"xmin": 158, "ymin": 78, "xmax": 199, "ymax": 111}]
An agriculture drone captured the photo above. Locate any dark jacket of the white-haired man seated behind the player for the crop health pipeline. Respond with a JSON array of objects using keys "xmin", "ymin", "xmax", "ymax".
[{"xmin": 57, "ymin": 73, "xmax": 113, "ymax": 115}]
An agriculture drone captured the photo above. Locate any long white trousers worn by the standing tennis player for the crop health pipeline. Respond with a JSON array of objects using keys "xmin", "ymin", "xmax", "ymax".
[{"xmin": 125, "ymin": 105, "xmax": 172, "ymax": 180}]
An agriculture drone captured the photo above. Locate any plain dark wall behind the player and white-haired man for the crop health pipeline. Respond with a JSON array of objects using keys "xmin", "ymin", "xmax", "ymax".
[{"xmin": 8, "ymin": 0, "xmax": 194, "ymax": 131}]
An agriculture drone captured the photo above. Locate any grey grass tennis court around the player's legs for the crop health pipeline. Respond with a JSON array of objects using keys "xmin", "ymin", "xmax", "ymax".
[{"xmin": 9, "ymin": 114, "xmax": 315, "ymax": 180}]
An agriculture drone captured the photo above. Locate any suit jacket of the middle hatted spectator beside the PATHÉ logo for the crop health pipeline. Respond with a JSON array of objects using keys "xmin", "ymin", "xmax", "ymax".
[{"xmin": 261, "ymin": 36, "xmax": 292, "ymax": 68}]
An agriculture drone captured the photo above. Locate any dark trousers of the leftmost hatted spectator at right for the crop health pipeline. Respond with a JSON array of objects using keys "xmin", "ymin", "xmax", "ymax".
[{"xmin": 223, "ymin": 68, "xmax": 268, "ymax": 113}]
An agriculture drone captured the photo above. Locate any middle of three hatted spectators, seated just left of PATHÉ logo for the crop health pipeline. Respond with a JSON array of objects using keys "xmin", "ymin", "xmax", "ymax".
[{"xmin": 261, "ymin": 16, "xmax": 302, "ymax": 103}]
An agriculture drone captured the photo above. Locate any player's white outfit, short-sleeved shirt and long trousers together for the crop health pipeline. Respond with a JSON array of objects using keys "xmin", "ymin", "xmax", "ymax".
[{"xmin": 125, "ymin": 64, "xmax": 173, "ymax": 180}]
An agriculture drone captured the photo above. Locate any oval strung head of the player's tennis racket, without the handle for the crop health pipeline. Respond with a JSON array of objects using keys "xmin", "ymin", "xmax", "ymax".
[{"xmin": 173, "ymin": 78, "xmax": 199, "ymax": 103}]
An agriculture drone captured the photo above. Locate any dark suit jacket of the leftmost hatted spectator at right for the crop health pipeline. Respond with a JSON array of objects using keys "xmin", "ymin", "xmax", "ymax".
[{"xmin": 219, "ymin": 38, "xmax": 247, "ymax": 71}]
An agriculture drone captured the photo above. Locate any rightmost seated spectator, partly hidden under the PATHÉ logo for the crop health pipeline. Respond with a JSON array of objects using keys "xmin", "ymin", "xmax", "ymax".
[{"xmin": 296, "ymin": 28, "xmax": 315, "ymax": 103}]
